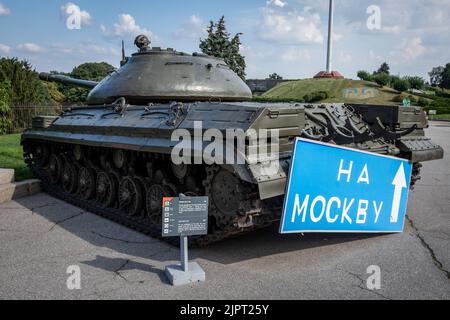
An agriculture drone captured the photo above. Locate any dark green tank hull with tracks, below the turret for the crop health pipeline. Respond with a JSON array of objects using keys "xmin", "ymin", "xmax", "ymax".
[{"xmin": 22, "ymin": 102, "xmax": 443, "ymax": 245}]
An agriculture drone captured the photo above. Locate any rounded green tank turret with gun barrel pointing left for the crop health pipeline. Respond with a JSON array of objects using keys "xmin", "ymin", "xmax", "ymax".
[{"xmin": 41, "ymin": 35, "xmax": 252, "ymax": 105}]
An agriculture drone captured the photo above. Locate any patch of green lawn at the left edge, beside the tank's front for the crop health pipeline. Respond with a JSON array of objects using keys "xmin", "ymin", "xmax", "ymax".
[{"xmin": 0, "ymin": 134, "xmax": 33, "ymax": 181}]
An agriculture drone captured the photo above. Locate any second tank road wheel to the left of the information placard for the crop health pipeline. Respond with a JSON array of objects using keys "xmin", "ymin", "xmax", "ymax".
[{"xmin": 119, "ymin": 177, "xmax": 143, "ymax": 216}]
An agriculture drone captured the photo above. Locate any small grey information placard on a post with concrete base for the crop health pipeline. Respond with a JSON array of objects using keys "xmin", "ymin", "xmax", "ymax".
[{"xmin": 162, "ymin": 195, "xmax": 208, "ymax": 286}]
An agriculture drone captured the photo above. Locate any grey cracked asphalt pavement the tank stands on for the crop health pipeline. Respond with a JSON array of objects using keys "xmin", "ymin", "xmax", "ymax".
[{"xmin": 0, "ymin": 122, "xmax": 450, "ymax": 299}]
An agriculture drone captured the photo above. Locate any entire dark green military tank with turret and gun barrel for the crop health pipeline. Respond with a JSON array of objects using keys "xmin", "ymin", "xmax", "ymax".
[{"xmin": 22, "ymin": 36, "xmax": 443, "ymax": 245}]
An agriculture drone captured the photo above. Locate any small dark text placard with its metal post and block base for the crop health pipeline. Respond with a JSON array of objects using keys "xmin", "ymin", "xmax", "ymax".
[{"xmin": 163, "ymin": 195, "xmax": 208, "ymax": 286}]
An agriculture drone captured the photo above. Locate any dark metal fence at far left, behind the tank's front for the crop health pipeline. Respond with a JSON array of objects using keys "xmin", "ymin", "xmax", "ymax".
[{"xmin": 8, "ymin": 104, "xmax": 62, "ymax": 133}]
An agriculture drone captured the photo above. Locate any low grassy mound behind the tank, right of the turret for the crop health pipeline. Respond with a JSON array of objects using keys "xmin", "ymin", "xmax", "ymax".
[{"xmin": 261, "ymin": 79, "xmax": 424, "ymax": 105}]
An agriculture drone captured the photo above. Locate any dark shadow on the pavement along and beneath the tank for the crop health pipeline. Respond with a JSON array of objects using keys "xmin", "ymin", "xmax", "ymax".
[{"xmin": 17, "ymin": 194, "xmax": 381, "ymax": 268}]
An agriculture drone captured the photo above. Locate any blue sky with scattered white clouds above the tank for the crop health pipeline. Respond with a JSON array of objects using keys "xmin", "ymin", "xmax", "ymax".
[{"xmin": 0, "ymin": 0, "xmax": 450, "ymax": 80}]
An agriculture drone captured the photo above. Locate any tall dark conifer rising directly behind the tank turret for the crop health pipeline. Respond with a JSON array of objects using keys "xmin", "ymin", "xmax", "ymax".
[{"xmin": 199, "ymin": 16, "xmax": 246, "ymax": 80}]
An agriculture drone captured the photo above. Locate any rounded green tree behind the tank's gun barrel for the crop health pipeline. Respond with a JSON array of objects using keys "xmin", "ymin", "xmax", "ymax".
[{"xmin": 56, "ymin": 62, "xmax": 115, "ymax": 104}]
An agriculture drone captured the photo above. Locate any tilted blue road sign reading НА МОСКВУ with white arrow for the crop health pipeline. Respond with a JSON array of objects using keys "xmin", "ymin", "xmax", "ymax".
[{"xmin": 280, "ymin": 138, "xmax": 412, "ymax": 233}]
